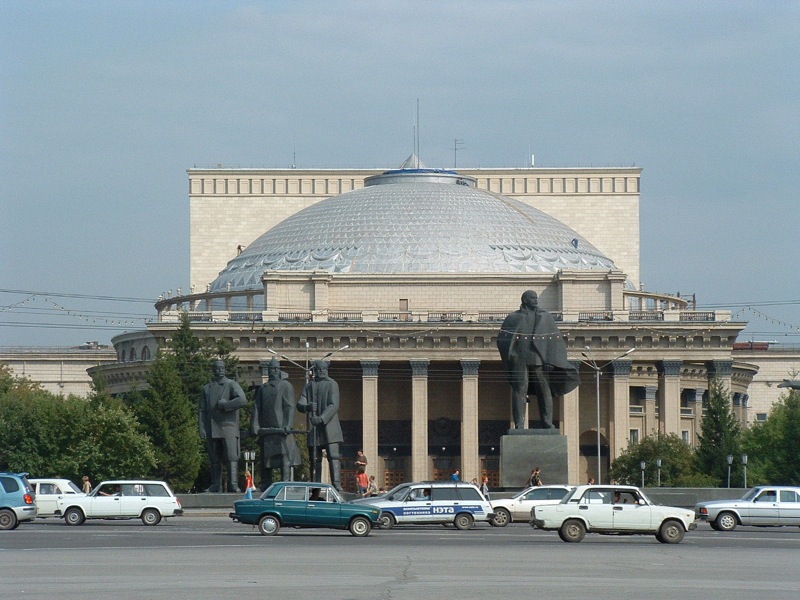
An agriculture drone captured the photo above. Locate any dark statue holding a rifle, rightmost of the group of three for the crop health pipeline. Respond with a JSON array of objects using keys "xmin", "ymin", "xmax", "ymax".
[{"xmin": 297, "ymin": 360, "xmax": 344, "ymax": 491}]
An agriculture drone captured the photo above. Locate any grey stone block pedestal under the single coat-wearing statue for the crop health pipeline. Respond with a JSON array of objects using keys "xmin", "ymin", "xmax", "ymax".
[{"xmin": 500, "ymin": 429, "xmax": 569, "ymax": 488}]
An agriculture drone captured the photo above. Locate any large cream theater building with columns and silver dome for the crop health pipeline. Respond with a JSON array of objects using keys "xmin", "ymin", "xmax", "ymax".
[{"xmin": 93, "ymin": 156, "xmax": 758, "ymax": 486}]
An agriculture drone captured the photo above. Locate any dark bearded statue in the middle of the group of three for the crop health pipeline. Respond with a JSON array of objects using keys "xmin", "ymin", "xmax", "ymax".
[{"xmin": 250, "ymin": 358, "xmax": 303, "ymax": 492}]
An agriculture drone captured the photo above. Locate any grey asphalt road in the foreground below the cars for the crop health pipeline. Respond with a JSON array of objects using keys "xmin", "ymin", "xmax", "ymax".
[{"xmin": 0, "ymin": 516, "xmax": 800, "ymax": 600}]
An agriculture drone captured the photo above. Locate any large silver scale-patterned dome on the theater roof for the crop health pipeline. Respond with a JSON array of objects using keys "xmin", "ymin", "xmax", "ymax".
[{"xmin": 211, "ymin": 169, "xmax": 615, "ymax": 292}]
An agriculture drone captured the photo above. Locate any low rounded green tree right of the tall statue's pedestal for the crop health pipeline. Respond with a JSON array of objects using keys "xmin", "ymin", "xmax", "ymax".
[{"xmin": 610, "ymin": 433, "xmax": 702, "ymax": 487}]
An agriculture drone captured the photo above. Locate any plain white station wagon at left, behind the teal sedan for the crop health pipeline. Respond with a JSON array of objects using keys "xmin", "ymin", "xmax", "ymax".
[{"xmin": 57, "ymin": 480, "xmax": 183, "ymax": 525}]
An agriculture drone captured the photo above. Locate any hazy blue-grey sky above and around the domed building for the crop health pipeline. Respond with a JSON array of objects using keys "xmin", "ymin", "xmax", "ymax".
[{"xmin": 0, "ymin": 0, "xmax": 800, "ymax": 346}]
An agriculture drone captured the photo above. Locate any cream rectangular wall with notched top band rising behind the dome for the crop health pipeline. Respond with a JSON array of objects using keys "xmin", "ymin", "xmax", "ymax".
[{"xmin": 189, "ymin": 167, "xmax": 641, "ymax": 292}]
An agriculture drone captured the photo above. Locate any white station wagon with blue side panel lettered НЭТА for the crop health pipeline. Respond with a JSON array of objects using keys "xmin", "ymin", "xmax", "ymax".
[{"xmin": 364, "ymin": 481, "xmax": 494, "ymax": 529}]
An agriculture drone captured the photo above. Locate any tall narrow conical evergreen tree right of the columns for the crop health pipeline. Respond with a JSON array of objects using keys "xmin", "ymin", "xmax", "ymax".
[{"xmin": 695, "ymin": 379, "xmax": 742, "ymax": 485}]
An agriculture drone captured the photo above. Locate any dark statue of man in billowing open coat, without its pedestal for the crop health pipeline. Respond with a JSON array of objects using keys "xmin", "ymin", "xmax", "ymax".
[{"xmin": 497, "ymin": 290, "xmax": 580, "ymax": 429}]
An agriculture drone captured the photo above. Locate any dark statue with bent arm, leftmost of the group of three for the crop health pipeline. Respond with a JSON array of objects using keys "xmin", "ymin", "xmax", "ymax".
[{"xmin": 199, "ymin": 360, "xmax": 247, "ymax": 492}]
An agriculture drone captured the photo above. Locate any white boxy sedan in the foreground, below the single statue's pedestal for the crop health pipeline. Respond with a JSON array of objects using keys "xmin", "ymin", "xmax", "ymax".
[{"xmin": 531, "ymin": 485, "xmax": 697, "ymax": 544}]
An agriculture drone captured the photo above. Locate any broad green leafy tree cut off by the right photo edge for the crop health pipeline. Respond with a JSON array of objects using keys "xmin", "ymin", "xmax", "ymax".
[{"xmin": 742, "ymin": 390, "xmax": 800, "ymax": 485}]
